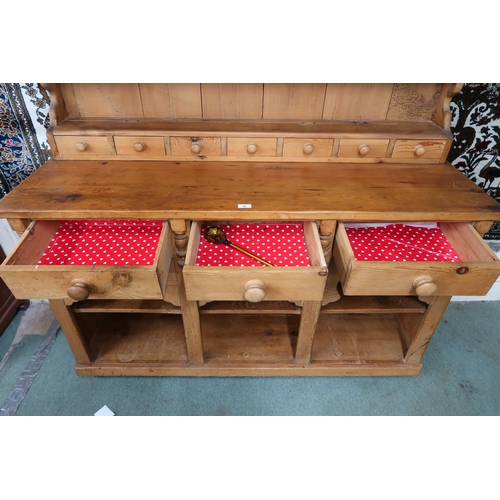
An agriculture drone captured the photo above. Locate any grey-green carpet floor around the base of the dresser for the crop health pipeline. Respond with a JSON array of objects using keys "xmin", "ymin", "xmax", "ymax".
[{"xmin": 0, "ymin": 302, "xmax": 500, "ymax": 416}]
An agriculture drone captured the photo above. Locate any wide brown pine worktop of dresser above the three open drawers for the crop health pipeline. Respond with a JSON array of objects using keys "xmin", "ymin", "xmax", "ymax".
[{"xmin": 0, "ymin": 160, "xmax": 500, "ymax": 221}]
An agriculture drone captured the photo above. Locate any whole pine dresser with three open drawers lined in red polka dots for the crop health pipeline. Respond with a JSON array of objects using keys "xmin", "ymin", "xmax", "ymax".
[{"xmin": 0, "ymin": 83, "xmax": 500, "ymax": 376}]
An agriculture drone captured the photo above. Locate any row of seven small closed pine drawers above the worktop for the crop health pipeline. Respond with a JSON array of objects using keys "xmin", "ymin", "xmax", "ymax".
[{"xmin": 55, "ymin": 136, "xmax": 446, "ymax": 159}]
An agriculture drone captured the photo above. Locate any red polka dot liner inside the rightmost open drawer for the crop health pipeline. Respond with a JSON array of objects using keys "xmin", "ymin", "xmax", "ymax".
[{"xmin": 344, "ymin": 223, "xmax": 461, "ymax": 262}]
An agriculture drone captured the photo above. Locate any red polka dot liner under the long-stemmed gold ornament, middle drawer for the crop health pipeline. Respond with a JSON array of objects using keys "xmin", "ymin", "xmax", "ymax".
[{"xmin": 196, "ymin": 223, "xmax": 311, "ymax": 267}]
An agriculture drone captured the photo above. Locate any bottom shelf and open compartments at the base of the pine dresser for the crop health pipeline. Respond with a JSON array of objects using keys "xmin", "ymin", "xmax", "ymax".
[{"xmin": 72, "ymin": 312, "xmax": 421, "ymax": 376}]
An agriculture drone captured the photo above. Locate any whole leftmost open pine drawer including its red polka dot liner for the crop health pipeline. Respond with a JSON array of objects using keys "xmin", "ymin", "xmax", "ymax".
[{"xmin": 0, "ymin": 220, "xmax": 172, "ymax": 301}]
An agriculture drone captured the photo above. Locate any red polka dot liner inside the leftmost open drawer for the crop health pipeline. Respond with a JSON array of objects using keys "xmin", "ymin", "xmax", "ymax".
[{"xmin": 38, "ymin": 220, "xmax": 163, "ymax": 266}]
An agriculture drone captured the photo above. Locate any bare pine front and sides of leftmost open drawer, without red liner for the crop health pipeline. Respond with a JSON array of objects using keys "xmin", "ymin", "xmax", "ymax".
[{"xmin": 0, "ymin": 221, "xmax": 172, "ymax": 300}]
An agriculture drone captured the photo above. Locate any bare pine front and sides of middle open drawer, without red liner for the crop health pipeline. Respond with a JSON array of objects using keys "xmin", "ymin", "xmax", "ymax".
[{"xmin": 182, "ymin": 222, "xmax": 328, "ymax": 302}]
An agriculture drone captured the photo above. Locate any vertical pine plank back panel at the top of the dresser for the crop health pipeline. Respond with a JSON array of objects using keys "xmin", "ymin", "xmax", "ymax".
[{"xmin": 56, "ymin": 83, "xmax": 455, "ymax": 121}]
